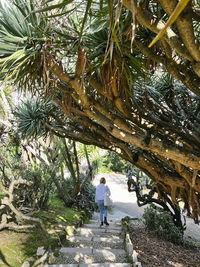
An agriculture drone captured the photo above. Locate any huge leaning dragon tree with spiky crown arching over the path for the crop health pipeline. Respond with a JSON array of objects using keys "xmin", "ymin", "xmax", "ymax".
[{"xmin": 0, "ymin": 0, "xmax": 200, "ymax": 222}]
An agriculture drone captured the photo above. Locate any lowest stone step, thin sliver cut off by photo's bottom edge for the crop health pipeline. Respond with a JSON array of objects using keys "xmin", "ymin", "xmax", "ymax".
[{"xmin": 42, "ymin": 263, "xmax": 132, "ymax": 267}]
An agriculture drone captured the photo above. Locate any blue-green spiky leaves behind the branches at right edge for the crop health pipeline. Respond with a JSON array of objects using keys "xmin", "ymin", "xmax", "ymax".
[{"xmin": 133, "ymin": 72, "xmax": 200, "ymax": 117}]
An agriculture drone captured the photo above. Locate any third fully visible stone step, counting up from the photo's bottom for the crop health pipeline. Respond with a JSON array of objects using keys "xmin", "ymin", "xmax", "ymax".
[{"xmin": 76, "ymin": 227, "xmax": 121, "ymax": 237}]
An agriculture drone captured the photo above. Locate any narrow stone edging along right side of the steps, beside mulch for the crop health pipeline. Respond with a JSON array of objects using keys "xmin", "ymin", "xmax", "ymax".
[{"xmin": 122, "ymin": 217, "xmax": 142, "ymax": 267}]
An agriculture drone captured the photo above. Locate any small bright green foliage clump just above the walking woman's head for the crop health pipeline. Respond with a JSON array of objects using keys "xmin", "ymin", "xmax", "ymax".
[{"xmin": 103, "ymin": 151, "xmax": 127, "ymax": 172}]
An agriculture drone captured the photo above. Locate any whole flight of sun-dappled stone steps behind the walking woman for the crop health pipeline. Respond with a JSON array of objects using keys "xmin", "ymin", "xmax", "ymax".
[{"xmin": 43, "ymin": 219, "xmax": 132, "ymax": 267}]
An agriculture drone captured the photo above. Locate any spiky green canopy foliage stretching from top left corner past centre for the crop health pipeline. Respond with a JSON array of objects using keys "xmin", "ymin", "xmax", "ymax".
[{"xmin": 0, "ymin": 0, "xmax": 144, "ymax": 91}]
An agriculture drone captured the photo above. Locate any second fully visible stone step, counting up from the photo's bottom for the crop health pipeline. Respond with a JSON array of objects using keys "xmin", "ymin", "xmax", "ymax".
[{"xmin": 67, "ymin": 236, "xmax": 123, "ymax": 248}]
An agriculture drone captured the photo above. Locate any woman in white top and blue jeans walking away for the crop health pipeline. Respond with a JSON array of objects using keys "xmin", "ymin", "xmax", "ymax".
[{"xmin": 95, "ymin": 177, "xmax": 111, "ymax": 226}]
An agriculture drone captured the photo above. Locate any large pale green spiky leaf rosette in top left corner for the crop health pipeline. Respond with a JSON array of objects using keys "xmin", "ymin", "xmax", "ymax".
[{"xmin": 0, "ymin": 0, "xmax": 48, "ymax": 89}]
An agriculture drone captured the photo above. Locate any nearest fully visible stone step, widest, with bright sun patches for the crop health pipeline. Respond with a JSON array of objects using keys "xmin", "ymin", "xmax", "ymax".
[{"xmin": 52, "ymin": 247, "xmax": 126, "ymax": 264}]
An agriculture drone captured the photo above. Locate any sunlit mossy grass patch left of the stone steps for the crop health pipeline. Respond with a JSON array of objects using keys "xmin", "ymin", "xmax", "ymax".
[{"xmin": 0, "ymin": 199, "xmax": 90, "ymax": 267}]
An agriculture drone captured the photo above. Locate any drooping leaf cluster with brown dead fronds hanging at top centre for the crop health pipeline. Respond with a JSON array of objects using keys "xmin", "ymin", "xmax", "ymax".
[{"xmin": 83, "ymin": 5, "xmax": 144, "ymax": 97}]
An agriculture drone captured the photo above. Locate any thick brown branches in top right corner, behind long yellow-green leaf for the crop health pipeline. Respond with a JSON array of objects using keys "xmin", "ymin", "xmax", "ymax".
[{"xmin": 123, "ymin": 0, "xmax": 200, "ymax": 95}]
